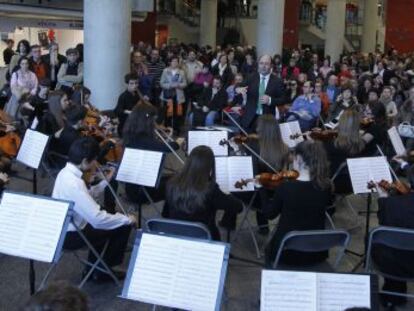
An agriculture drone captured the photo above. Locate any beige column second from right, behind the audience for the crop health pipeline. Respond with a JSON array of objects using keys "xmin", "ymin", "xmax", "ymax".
[{"xmin": 325, "ymin": 0, "xmax": 346, "ymax": 62}]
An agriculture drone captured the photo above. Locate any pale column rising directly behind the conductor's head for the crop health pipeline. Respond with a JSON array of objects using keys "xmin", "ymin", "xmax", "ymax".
[{"xmin": 256, "ymin": 0, "xmax": 285, "ymax": 56}]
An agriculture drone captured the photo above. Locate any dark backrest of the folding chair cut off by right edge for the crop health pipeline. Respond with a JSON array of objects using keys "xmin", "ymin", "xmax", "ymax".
[{"xmin": 365, "ymin": 226, "xmax": 414, "ymax": 271}]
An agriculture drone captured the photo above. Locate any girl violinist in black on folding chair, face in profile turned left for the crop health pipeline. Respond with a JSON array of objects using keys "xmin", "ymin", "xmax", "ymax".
[{"xmin": 264, "ymin": 141, "xmax": 332, "ymax": 266}]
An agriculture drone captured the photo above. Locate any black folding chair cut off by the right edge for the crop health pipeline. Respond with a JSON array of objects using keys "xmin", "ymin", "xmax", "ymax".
[{"xmin": 365, "ymin": 226, "xmax": 414, "ymax": 298}]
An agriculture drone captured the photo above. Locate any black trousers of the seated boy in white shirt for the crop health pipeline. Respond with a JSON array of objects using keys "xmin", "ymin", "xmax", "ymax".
[{"xmin": 63, "ymin": 224, "xmax": 131, "ymax": 267}]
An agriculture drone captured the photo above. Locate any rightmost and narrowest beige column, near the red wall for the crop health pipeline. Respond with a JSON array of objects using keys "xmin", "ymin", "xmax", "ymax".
[{"xmin": 361, "ymin": 0, "xmax": 378, "ymax": 53}]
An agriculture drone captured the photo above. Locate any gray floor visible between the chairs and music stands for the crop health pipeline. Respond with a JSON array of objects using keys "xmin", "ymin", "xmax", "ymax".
[{"xmin": 0, "ymin": 158, "xmax": 414, "ymax": 311}]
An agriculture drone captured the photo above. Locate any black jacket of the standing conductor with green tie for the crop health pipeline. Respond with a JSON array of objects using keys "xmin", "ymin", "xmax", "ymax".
[{"xmin": 241, "ymin": 73, "xmax": 286, "ymax": 128}]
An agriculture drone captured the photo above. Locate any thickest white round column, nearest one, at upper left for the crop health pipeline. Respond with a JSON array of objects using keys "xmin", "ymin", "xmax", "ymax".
[{"xmin": 84, "ymin": 0, "xmax": 131, "ymax": 110}]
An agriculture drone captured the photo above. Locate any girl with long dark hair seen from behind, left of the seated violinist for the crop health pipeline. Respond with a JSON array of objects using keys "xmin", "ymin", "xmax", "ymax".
[{"xmin": 163, "ymin": 146, "xmax": 243, "ymax": 240}]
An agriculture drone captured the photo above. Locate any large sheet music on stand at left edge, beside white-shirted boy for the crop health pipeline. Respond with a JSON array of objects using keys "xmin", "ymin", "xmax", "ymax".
[{"xmin": 0, "ymin": 192, "xmax": 69, "ymax": 262}]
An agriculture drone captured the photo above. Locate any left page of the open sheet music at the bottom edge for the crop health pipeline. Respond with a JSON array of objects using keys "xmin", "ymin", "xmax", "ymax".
[{"xmin": 260, "ymin": 270, "xmax": 318, "ymax": 311}]
